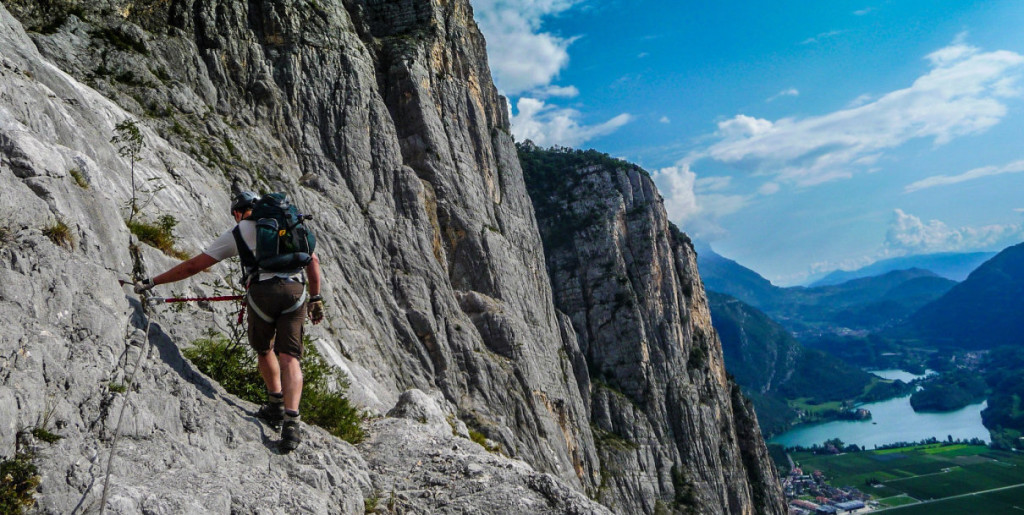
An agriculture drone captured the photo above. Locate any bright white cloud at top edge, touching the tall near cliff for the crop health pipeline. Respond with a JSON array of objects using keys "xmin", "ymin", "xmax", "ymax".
[{"xmin": 472, "ymin": 0, "xmax": 579, "ymax": 95}]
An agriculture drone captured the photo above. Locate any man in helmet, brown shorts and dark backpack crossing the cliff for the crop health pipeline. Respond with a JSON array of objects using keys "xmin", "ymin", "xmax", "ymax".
[{"xmin": 135, "ymin": 191, "xmax": 324, "ymax": 453}]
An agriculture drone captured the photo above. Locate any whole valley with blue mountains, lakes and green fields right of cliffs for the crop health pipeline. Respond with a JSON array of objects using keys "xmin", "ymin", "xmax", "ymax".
[{"xmin": 698, "ymin": 239, "xmax": 1024, "ymax": 515}]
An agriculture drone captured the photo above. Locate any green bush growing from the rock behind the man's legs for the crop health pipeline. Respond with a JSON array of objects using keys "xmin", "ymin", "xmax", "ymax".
[{"xmin": 184, "ymin": 333, "xmax": 366, "ymax": 443}]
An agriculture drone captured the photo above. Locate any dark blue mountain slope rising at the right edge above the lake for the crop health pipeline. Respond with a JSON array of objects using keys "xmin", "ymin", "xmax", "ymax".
[{"xmin": 890, "ymin": 244, "xmax": 1024, "ymax": 349}]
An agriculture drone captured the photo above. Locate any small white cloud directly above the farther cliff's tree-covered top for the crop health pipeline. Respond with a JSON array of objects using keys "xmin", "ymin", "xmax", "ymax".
[{"xmin": 511, "ymin": 98, "xmax": 633, "ymax": 146}]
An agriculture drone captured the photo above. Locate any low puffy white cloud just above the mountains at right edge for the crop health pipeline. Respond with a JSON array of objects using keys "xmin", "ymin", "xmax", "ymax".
[{"xmin": 886, "ymin": 209, "xmax": 1024, "ymax": 255}]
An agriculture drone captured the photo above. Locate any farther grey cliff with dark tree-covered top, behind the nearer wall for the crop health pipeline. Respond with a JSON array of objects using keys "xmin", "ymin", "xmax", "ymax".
[{"xmin": 520, "ymin": 142, "xmax": 785, "ymax": 513}]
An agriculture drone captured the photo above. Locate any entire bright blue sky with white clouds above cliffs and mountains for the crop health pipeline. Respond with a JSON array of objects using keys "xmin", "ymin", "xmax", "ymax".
[{"xmin": 472, "ymin": 0, "xmax": 1024, "ymax": 285}]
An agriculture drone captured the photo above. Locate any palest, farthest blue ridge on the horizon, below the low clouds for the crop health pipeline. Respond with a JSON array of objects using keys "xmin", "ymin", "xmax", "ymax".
[{"xmin": 810, "ymin": 252, "xmax": 995, "ymax": 288}]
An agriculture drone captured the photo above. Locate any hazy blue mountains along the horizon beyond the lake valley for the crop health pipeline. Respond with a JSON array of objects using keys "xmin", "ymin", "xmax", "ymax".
[{"xmin": 696, "ymin": 239, "xmax": 1024, "ymax": 349}]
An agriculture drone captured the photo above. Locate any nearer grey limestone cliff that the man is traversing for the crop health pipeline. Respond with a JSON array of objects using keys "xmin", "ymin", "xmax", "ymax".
[{"xmin": 0, "ymin": 0, "xmax": 774, "ymax": 513}]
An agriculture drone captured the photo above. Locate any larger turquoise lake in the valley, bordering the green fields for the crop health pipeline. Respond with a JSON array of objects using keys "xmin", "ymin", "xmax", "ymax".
[{"xmin": 769, "ymin": 395, "xmax": 991, "ymax": 448}]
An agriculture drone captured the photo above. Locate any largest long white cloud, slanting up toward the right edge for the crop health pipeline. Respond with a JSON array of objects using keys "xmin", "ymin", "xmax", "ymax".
[{"xmin": 681, "ymin": 39, "xmax": 1024, "ymax": 185}]
